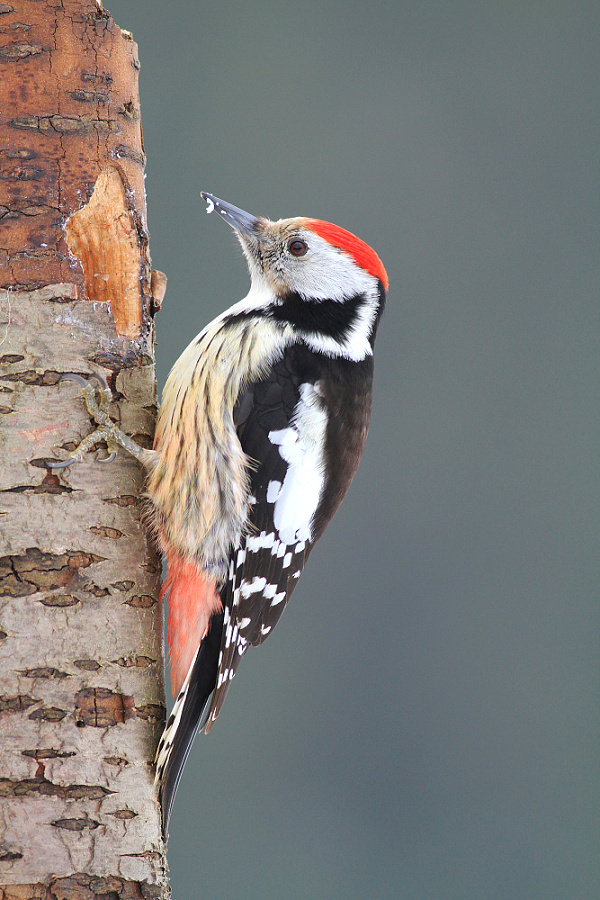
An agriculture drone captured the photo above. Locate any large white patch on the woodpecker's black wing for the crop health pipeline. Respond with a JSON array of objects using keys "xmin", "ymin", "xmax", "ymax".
[{"xmin": 267, "ymin": 382, "xmax": 327, "ymax": 544}]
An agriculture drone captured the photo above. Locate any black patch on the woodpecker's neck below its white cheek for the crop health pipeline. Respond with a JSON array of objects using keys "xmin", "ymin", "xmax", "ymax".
[{"xmin": 268, "ymin": 293, "xmax": 367, "ymax": 343}]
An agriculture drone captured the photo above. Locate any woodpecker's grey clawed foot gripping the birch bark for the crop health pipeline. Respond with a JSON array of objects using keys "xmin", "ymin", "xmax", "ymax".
[{"xmin": 47, "ymin": 372, "xmax": 155, "ymax": 469}]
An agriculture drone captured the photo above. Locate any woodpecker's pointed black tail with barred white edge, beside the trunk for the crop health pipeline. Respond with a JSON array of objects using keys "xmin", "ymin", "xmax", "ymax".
[{"xmin": 156, "ymin": 613, "xmax": 223, "ymax": 837}]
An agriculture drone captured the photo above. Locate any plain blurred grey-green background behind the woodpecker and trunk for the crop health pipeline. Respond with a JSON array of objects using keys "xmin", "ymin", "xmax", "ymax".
[{"xmin": 107, "ymin": 0, "xmax": 600, "ymax": 900}]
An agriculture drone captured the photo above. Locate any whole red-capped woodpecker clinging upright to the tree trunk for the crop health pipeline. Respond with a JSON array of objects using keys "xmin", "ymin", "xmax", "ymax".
[{"xmin": 50, "ymin": 192, "xmax": 388, "ymax": 834}]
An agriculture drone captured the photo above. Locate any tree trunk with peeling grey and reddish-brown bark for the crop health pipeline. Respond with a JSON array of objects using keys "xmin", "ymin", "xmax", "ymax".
[{"xmin": 0, "ymin": 0, "xmax": 168, "ymax": 900}]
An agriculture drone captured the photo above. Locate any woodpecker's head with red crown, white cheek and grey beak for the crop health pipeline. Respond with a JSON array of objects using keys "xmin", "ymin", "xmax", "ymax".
[{"xmin": 202, "ymin": 192, "xmax": 388, "ymax": 360}]
